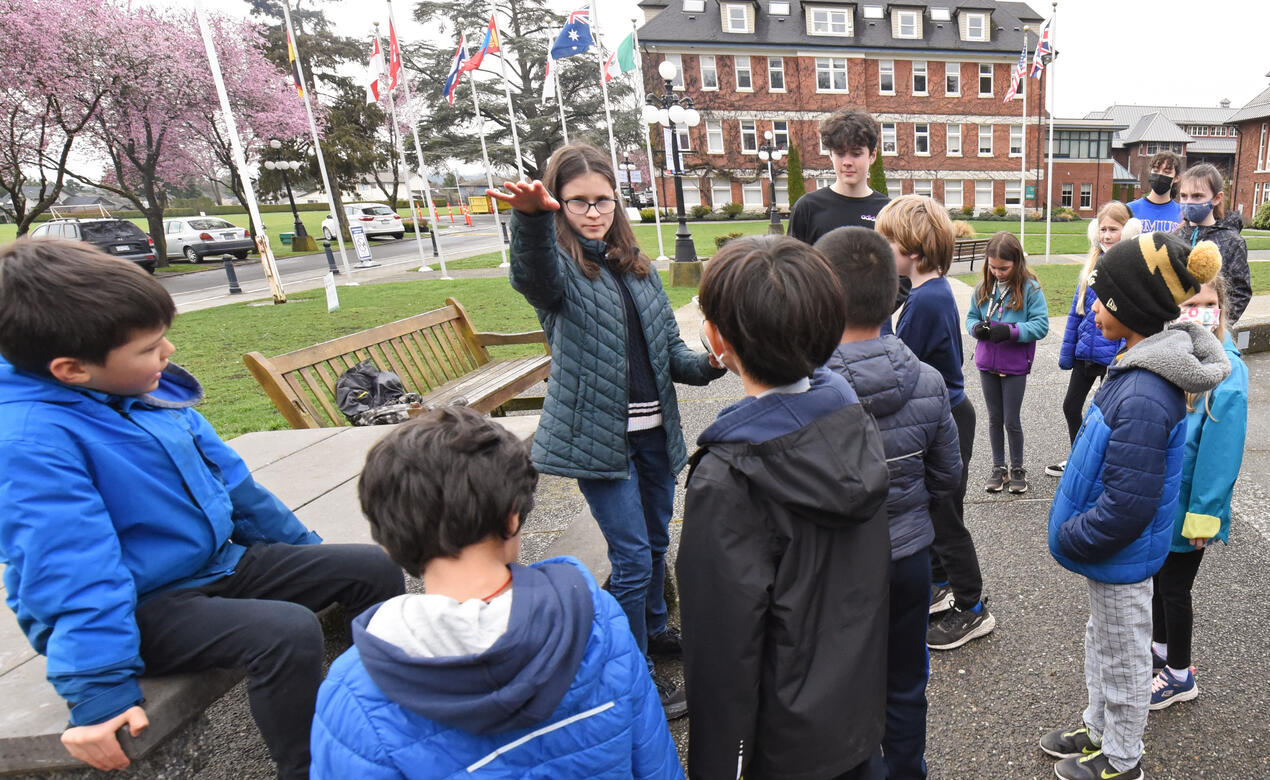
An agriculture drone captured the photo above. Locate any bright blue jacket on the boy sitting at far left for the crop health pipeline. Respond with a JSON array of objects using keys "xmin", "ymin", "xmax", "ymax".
[{"xmin": 0, "ymin": 358, "xmax": 321, "ymax": 725}]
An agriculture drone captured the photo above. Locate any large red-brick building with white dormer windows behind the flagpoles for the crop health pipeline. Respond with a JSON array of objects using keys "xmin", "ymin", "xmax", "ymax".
[{"xmin": 639, "ymin": 0, "xmax": 1092, "ymax": 212}]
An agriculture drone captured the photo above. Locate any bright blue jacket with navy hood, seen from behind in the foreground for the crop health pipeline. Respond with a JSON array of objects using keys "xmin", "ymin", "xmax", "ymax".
[{"xmin": 310, "ymin": 558, "xmax": 683, "ymax": 780}]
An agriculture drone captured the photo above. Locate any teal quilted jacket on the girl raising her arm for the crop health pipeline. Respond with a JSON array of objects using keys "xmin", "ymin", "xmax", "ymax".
[{"xmin": 511, "ymin": 211, "xmax": 724, "ymax": 479}]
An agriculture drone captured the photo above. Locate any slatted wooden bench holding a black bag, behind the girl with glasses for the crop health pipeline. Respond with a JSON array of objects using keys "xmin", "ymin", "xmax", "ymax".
[{"xmin": 243, "ymin": 297, "xmax": 551, "ymax": 428}]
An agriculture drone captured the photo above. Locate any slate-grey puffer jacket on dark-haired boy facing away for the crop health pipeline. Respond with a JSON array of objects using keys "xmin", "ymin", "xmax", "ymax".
[{"xmin": 824, "ymin": 335, "xmax": 961, "ymax": 560}]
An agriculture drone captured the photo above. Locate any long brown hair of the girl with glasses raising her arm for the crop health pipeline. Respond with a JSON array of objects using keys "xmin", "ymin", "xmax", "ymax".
[{"xmin": 542, "ymin": 144, "xmax": 652, "ymax": 279}]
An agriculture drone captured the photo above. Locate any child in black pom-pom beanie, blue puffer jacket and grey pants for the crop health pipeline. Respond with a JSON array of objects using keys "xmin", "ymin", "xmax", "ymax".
[{"xmin": 1040, "ymin": 232, "xmax": 1231, "ymax": 780}]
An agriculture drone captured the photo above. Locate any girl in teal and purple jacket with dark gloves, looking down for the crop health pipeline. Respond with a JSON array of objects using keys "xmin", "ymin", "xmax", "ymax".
[{"xmin": 965, "ymin": 231, "xmax": 1049, "ymax": 493}]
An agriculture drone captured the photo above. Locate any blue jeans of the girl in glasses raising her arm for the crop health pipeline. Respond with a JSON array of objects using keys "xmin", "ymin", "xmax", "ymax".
[{"xmin": 578, "ymin": 428, "xmax": 674, "ymax": 654}]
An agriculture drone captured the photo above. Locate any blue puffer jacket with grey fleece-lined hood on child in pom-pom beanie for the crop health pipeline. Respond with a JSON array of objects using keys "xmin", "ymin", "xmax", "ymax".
[{"xmin": 1049, "ymin": 323, "xmax": 1231, "ymax": 583}]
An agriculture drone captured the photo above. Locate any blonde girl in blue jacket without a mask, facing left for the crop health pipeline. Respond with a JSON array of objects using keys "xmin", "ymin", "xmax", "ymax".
[{"xmin": 1045, "ymin": 201, "xmax": 1142, "ymax": 476}]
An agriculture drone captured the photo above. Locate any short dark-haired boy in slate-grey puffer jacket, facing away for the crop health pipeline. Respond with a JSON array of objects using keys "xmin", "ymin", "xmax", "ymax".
[{"xmin": 815, "ymin": 227, "xmax": 961, "ymax": 779}]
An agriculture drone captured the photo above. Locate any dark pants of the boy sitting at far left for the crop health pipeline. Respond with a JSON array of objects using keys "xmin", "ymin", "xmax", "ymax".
[{"xmin": 136, "ymin": 544, "xmax": 405, "ymax": 777}]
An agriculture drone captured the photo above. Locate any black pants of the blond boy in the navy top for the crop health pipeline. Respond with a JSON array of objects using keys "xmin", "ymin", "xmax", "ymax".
[{"xmin": 931, "ymin": 398, "xmax": 983, "ymax": 610}]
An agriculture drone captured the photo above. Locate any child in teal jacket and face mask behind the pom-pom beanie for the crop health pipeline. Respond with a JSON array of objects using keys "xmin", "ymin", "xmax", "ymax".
[{"xmin": 1151, "ymin": 277, "xmax": 1248, "ymax": 710}]
